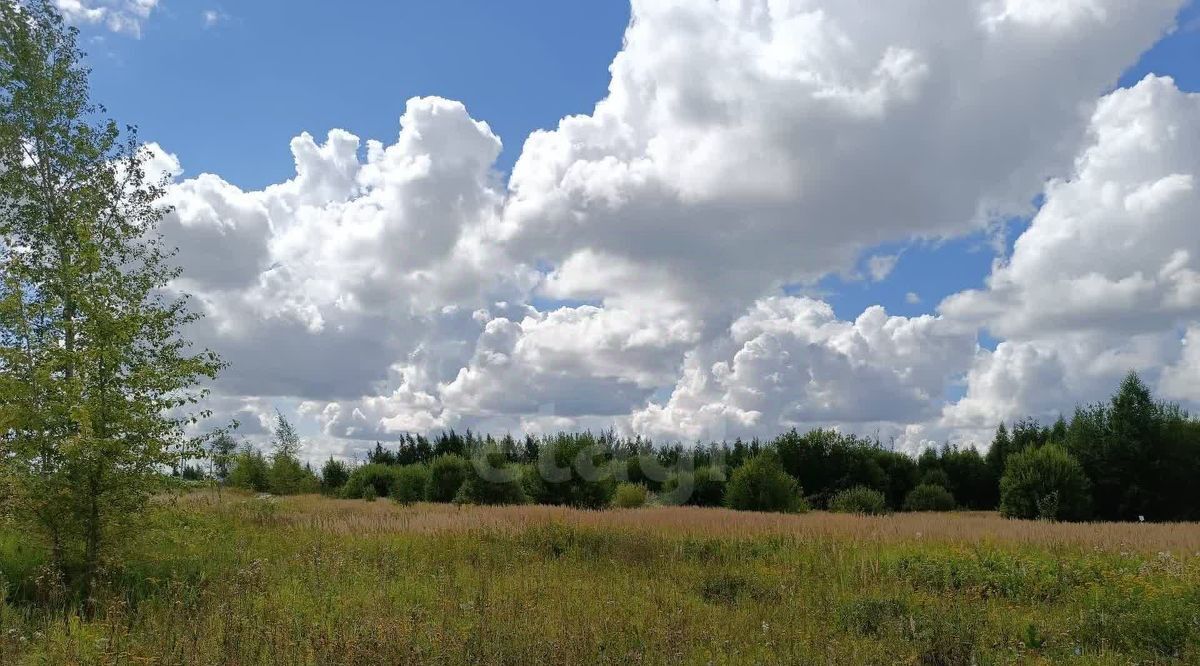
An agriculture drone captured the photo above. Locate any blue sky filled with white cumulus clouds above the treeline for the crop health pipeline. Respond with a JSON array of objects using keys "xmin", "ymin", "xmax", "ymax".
[{"xmin": 58, "ymin": 0, "xmax": 1200, "ymax": 458}]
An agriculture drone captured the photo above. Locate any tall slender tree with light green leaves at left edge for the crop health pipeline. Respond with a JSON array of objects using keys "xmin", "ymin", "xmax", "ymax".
[{"xmin": 0, "ymin": 1, "xmax": 222, "ymax": 604}]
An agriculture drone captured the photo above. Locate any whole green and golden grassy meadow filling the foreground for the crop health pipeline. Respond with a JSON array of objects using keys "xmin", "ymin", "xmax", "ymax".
[{"xmin": 0, "ymin": 493, "xmax": 1200, "ymax": 665}]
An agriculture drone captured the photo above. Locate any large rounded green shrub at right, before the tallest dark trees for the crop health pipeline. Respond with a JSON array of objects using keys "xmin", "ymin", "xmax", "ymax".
[{"xmin": 1000, "ymin": 444, "xmax": 1091, "ymax": 521}]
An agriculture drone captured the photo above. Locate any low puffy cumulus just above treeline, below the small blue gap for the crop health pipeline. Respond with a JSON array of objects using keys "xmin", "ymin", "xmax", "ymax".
[{"xmin": 631, "ymin": 296, "xmax": 976, "ymax": 448}]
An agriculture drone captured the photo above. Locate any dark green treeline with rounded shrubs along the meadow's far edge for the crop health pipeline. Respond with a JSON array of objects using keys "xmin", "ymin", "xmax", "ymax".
[{"xmin": 217, "ymin": 374, "xmax": 1200, "ymax": 521}]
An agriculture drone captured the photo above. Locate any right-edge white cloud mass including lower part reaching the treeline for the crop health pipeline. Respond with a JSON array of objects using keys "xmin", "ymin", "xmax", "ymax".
[{"xmin": 938, "ymin": 77, "xmax": 1200, "ymax": 431}]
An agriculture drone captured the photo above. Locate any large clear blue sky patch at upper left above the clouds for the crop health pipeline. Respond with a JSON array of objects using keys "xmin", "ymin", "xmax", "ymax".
[{"xmin": 86, "ymin": 0, "xmax": 629, "ymax": 188}]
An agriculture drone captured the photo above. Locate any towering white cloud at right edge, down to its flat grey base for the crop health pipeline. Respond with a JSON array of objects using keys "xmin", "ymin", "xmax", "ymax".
[{"xmin": 942, "ymin": 77, "xmax": 1200, "ymax": 337}]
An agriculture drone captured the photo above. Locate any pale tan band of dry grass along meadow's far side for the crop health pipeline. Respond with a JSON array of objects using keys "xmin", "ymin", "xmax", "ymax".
[{"xmin": 184, "ymin": 493, "xmax": 1200, "ymax": 557}]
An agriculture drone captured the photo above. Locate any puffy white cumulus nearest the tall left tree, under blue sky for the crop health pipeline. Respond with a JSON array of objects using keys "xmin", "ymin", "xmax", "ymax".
[{"xmin": 162, "ymin": 98, "xmax": 520, "ymax": 412}]
